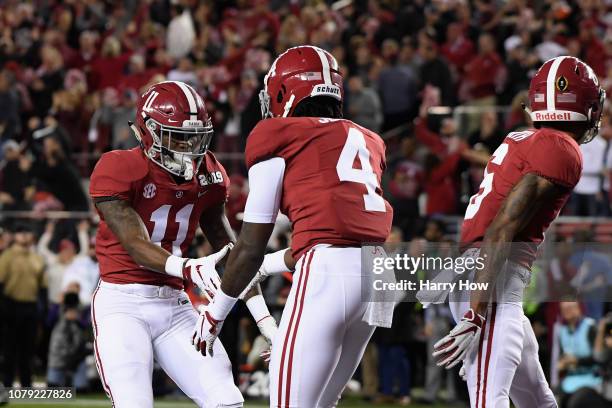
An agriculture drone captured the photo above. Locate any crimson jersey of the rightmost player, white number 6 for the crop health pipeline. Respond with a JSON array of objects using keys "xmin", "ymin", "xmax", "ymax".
[{"xmin": 461, "ymin": 128, "xmax": 582, "ymax": 265}]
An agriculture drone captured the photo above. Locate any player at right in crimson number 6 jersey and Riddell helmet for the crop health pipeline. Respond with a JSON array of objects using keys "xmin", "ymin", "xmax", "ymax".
[{"xmin": 434, "ymin": 56, "xmax": 605, "ymax": 408}]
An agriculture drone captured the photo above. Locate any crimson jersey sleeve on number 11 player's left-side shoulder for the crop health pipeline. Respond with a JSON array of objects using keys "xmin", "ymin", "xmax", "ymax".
[{"xmin": 89, "ymin": 151, "xmax": 146, "ymax": 202}]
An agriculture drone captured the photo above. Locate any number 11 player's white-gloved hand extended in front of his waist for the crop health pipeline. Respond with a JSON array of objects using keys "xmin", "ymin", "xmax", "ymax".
[{"xmin": 183, "ymin": 243, "xmax": 234, "ymax": 302}]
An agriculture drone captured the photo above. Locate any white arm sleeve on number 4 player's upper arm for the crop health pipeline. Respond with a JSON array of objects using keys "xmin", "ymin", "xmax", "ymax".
[{"xmin": 243, "ymin": 157, "xmax": 285, "ymax": 224}]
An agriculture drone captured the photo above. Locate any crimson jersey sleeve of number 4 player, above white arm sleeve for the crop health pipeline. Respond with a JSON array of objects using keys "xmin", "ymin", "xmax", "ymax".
[{"xmin": 245, "ymin": 118, "xmax": 298, "ymax": 169}]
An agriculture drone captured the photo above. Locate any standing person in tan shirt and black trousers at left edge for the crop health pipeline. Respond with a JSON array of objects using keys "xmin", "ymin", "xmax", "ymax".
[{"xmin": 0, "ymin": 224, "xmax": 47, "ymax": 387}]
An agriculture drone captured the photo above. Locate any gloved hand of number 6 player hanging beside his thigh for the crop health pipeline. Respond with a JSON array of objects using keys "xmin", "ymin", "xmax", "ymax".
[{"xmin": 432, "ymin": 309, "xmax": 485, "ymax": 369}]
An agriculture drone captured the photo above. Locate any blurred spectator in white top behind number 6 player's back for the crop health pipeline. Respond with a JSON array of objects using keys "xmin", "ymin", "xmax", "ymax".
[{"xmin": 569, "ymin": 135, "xmax": 606, "ymax": 216}]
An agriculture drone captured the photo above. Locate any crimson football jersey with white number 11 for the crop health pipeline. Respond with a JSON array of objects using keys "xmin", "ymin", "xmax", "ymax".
[{"xmin": 89, "ymin": 147, "xmax": 229, "ymax": 288}]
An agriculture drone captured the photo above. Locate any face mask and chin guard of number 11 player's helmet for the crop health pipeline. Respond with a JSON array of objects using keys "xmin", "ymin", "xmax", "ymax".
[{"xmin": 145, "ymin": 118, "xmax": 213, "ymax": 180}]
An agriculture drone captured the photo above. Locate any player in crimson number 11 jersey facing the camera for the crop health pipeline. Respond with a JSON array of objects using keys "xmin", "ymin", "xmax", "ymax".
[{"xmin": 90, "ymin": 81, "xmax": 276, "ymax": 408}]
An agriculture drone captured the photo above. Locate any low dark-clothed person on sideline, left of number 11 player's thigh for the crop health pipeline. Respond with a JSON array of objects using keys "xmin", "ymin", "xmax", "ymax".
[{"xmin": 47, "ymin": 292, "xmax": 88, "ymax": 391}]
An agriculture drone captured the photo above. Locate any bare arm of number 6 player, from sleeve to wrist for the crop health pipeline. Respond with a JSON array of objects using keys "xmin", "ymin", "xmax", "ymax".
[{"xmin": 470, "ymin": 173, "xmax": 566, "ymax": 315}]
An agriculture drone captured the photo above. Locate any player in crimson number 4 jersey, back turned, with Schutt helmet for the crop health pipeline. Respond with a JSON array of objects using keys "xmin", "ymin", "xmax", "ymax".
[{"xmin": 189, "ymin": 46, "xmax": 393, "ymax": 408}]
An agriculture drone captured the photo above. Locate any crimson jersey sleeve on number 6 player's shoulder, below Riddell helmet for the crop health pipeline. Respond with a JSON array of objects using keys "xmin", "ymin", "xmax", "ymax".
[{"xmin": 526, "ymin": 134, "xmax": 582, "ymax": 188}]
